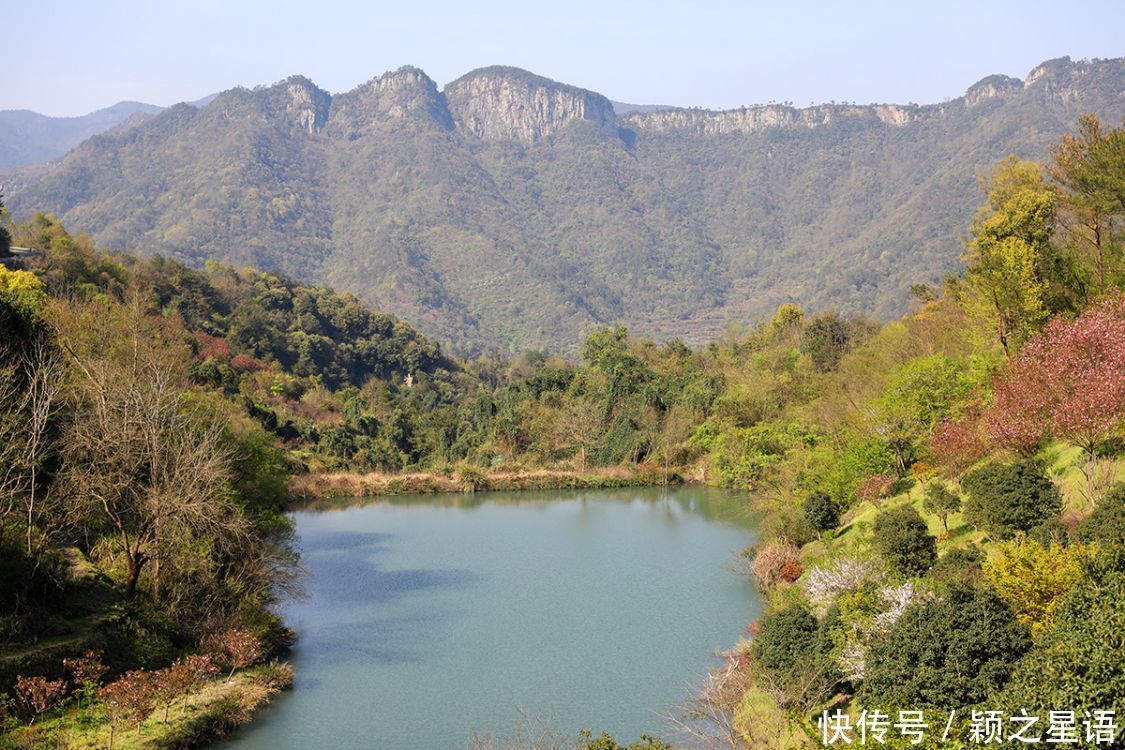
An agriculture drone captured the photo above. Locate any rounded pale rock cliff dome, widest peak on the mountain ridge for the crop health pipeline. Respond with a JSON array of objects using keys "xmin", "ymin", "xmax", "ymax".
[{"xmin": 444, "ymin": 65, "xmax": 618, "ymax": 143}]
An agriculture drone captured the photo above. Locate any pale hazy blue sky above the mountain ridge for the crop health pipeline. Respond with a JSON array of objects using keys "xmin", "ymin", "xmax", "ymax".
[{"xmin": 8, "ymin": 0, "xmax": 1125, "ymax": 115}]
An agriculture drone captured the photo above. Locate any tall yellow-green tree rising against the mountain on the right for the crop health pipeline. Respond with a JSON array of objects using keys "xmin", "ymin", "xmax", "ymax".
[{"xmin": 964, "ymin": 155, "xmax": 1062, "ymax": 355}]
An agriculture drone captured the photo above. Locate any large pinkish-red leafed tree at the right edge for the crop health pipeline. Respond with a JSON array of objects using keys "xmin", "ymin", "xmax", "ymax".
[{"xmin": 984, "ymin": 292, "xmax": 1125, "ymax": 453}]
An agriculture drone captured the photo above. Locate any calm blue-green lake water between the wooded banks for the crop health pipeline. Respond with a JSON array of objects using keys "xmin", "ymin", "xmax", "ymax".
[{"xmin": 221, "ymin": 488, "xmax": 759, "ymax": 750}]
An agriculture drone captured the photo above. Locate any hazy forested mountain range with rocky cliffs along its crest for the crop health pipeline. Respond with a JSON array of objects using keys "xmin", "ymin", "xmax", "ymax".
[{"xmin": 8, "ymin": 58, "xmax": 1125, "ymax": 352}]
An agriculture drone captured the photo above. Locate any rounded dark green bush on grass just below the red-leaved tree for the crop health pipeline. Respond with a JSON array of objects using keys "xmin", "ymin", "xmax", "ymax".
[{"xmin": 962, "ymin": 459, "xmax": 1062, "ymax": 539}]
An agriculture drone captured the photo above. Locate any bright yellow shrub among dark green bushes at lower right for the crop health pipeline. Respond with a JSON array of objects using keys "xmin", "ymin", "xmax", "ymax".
[{"xmin": 983, "ymin": 534, "xmax": 1097, "ymax": 639}]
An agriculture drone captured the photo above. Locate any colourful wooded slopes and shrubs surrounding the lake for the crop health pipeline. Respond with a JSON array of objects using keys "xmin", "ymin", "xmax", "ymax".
[{"xmin": 0, "ymin": 113, "xmax": 1125, "ymax": 748}]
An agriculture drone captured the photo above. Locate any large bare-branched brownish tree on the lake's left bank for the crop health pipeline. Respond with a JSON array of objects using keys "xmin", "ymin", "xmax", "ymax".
[{"xmin": 63, "ymin": 308, "xmax": 251, "ymax": 599}]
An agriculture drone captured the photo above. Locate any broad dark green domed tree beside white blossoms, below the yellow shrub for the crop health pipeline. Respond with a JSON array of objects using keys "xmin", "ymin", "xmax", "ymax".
[{"xmin": 860, "ymin": 584, "xmax": 1031, "ymax": 708}]
